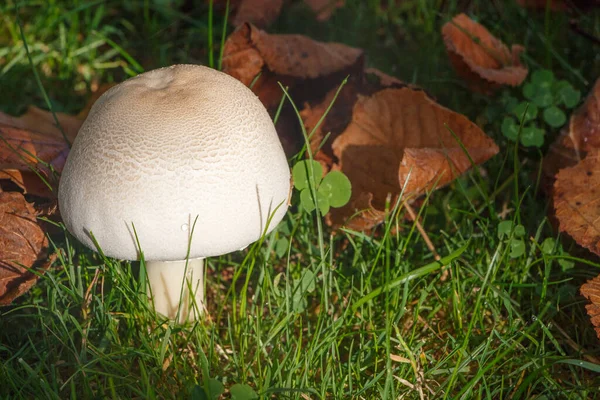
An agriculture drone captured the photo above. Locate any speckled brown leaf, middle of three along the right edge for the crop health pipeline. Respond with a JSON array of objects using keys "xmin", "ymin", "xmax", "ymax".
[{"xmin": 554, "ymin": 149, "xmax": 600, "ymax": 255}]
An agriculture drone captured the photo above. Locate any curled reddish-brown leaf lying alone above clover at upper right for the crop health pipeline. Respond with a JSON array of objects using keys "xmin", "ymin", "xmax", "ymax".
[{"xmin": 442, "ymin": 14, "xmax": 528, "ymax": 92}]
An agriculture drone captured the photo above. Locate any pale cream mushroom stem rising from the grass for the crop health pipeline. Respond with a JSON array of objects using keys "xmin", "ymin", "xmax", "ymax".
[{"xmin": 146, "ymin": 258, "xmax": 204, "ymax": 323}]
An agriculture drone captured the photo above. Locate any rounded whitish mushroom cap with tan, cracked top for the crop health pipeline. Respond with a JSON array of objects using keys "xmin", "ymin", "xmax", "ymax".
[{"xmin": 58, "ymin": 65, "xmax": 290, "ymax": 261}]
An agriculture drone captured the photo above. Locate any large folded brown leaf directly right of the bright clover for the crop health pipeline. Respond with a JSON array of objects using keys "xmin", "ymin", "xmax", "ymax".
[{"xmin": 329, "ymin": 87, "xmax": 498, "ymax": 229}]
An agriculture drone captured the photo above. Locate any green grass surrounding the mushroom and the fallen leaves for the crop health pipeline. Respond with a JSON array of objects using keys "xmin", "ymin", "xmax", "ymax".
[{"xmin": 0, "ymin": 0, "xmax": 600, "ymax": 399}]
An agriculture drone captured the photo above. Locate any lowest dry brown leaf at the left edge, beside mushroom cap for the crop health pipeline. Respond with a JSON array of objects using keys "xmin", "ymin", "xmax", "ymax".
[{"xmin": 0, "ymin": 192, "xmax": 53, "ymax": 306}]
